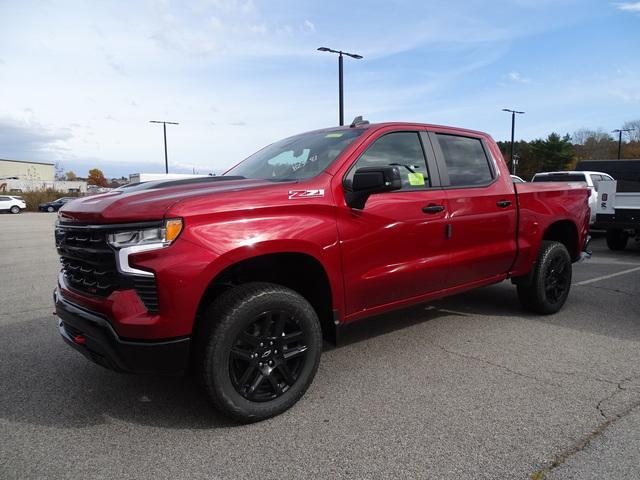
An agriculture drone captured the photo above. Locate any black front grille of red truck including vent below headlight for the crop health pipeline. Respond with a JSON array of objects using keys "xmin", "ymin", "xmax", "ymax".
[{"xmin": 55, "ymin": 221, "xmax": 158, "ymax": 312}]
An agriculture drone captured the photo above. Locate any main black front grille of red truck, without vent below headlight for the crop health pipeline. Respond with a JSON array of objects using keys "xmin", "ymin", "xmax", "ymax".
[{"xmin": 56, "ymin": 226, "xmax": 120, "ymax": 297}]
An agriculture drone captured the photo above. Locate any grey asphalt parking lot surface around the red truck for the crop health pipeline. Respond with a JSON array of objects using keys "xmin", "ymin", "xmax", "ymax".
[{"xmin": 0, "ymin": 213, "xmax": 640, "ymax": 479}]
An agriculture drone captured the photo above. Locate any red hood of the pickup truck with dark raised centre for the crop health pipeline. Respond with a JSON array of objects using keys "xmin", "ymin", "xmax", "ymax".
[{"xmin": 58, "ymin": 176, "xmax": 277, "ymax": 224}]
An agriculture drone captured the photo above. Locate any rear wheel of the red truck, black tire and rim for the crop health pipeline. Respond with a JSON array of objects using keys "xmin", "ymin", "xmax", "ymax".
[{"xmin": 518, "ymin": 240, "xmax": 571, "ymax": 315}]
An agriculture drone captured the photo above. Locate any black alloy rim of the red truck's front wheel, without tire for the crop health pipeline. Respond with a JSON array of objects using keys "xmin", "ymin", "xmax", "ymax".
[{"xmin": 229, "ymin": 310, "xmax": 308, "ymax": 402}]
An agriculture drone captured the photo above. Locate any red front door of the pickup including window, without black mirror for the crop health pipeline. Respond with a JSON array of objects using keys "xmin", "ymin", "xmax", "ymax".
[{"xmin": 338, "ymin": 130, "xmax": 448, "ymax": 315}]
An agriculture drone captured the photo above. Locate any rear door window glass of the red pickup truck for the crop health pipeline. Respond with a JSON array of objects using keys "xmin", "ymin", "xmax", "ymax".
[{"xmin": 436, "ymin": 133, "xmax": 493, "ymax": 187}]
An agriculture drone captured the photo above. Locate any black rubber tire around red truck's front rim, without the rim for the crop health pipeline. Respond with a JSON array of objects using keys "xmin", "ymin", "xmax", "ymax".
[{"xmin": 194, "ymin": 282, "xmax": 322, "ymax": 423}]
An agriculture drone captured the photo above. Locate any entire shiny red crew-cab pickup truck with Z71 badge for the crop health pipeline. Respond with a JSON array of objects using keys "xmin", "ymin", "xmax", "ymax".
[{"xmin": 54, "ymin": 121, "xmax": 589, "ymax": 422}]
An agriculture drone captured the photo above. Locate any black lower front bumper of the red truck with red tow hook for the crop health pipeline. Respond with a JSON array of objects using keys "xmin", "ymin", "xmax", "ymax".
[{"xmin": 53, "ymin": 290, "xmax": 190, "ymax": 374}]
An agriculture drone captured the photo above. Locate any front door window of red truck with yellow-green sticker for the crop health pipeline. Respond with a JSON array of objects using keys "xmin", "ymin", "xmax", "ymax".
[{"xmin": 345, "ymin": 132, "xmax": 430, "ymax": 190}]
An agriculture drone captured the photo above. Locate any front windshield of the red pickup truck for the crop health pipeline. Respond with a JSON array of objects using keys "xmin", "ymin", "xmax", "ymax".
[{"xmin": 224, "ymin": 128, "xmax": 364, "ymax": 181}]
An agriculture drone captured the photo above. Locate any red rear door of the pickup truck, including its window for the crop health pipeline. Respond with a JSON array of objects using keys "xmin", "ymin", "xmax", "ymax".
[{"xmin": 429, "ymin": 132, "xmax": 516, "ymax": 287}]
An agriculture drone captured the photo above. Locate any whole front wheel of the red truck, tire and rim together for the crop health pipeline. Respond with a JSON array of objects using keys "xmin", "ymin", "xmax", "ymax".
[{"xmin": 195, "ymin": 282, "xmax": 322, "ymax": 423}]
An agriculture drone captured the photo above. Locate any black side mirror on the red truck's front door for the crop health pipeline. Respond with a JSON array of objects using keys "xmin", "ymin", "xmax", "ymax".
[{"xmin": 344, "ymin": 165, "xmax": 402, "ymax": 210}]
